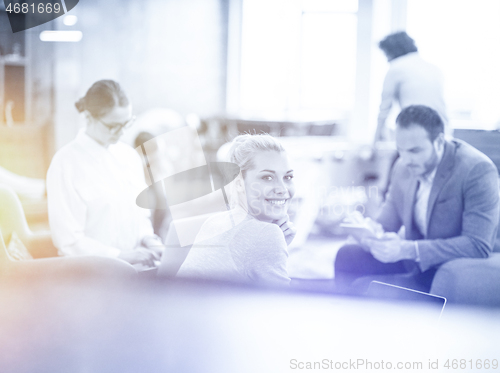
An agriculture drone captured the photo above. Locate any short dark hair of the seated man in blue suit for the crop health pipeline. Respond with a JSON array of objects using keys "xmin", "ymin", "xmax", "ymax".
[{"xmin": 396, "ymin": 105, "xmax": 444, "ymax": 142}]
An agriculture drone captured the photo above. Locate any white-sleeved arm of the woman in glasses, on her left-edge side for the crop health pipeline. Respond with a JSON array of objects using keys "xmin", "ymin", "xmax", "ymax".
[{"xmin": 47, "ymin": 158, "xmax": 120, "ymax": 258}]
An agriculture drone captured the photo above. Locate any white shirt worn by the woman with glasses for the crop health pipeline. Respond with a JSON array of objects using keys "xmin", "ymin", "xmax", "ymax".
[{"xmin": 47, "ymin": 131, "xmax": 154, "ymax": 257}]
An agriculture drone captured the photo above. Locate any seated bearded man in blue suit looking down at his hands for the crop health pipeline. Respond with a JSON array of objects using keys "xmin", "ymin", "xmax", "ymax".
[{"xmin": 335, "ymin": 105, "xmax": 499, "ymax": 293}]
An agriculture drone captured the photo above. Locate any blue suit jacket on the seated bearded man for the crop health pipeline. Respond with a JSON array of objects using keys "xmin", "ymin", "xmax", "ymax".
[{"xmin": 377, "ymin": 140, "xmax": 499, "ymax": 271}]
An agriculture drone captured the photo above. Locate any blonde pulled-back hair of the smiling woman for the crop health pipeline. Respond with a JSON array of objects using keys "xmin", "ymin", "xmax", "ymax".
[{"xmin": 229, "ymin": 133, "xmax": 285, "ymax": 177}]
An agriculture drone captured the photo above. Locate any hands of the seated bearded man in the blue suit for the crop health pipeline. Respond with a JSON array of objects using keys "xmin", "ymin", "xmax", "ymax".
[{"xmin": 362, "ymin": 232, "xmax": 417, "ymax": 263}]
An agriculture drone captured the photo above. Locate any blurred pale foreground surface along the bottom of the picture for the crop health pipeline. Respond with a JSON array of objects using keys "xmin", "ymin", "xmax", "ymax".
[{"xmin": 0, "ymin": 279, "xmax": 500, "ymax": 373}]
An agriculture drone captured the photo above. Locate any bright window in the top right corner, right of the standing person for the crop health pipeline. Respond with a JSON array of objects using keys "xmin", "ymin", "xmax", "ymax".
[{"xmin": 407, "ymin": 0, "xmax": 500, "ymax": 129}]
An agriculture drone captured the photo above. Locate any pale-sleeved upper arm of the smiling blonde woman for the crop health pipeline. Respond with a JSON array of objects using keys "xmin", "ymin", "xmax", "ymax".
[{"xmin": 245, "ymin": 224, "xmax": 290, "ymax": 286}]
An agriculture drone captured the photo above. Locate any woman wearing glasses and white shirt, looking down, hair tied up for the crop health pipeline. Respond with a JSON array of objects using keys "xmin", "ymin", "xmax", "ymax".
[{"xmin": 47, "ymin": 80, "xmax": 161, "ymax": 266}]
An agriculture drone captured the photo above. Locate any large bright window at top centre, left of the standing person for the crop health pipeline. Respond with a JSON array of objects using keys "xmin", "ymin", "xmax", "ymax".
[{"xmin": 237, "ymin": 0, "xmax": 358, "ymax": 119}]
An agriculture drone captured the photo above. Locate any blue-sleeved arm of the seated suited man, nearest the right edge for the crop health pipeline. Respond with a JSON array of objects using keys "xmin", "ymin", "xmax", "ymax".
[{"xmin": 417, "ymin": 162, "xmax": 499, "ymax": 271}]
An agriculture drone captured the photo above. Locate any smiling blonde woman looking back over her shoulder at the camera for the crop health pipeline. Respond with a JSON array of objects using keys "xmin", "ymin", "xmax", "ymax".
[{"xmin": 177, "ymin": 135, "xmax": 295, "ymax": 286}]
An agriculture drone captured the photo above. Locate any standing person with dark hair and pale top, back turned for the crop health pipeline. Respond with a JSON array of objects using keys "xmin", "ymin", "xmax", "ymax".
[{"xmin": 375, "ymin": 31, "xmax": 448, "ymax": 141}]
